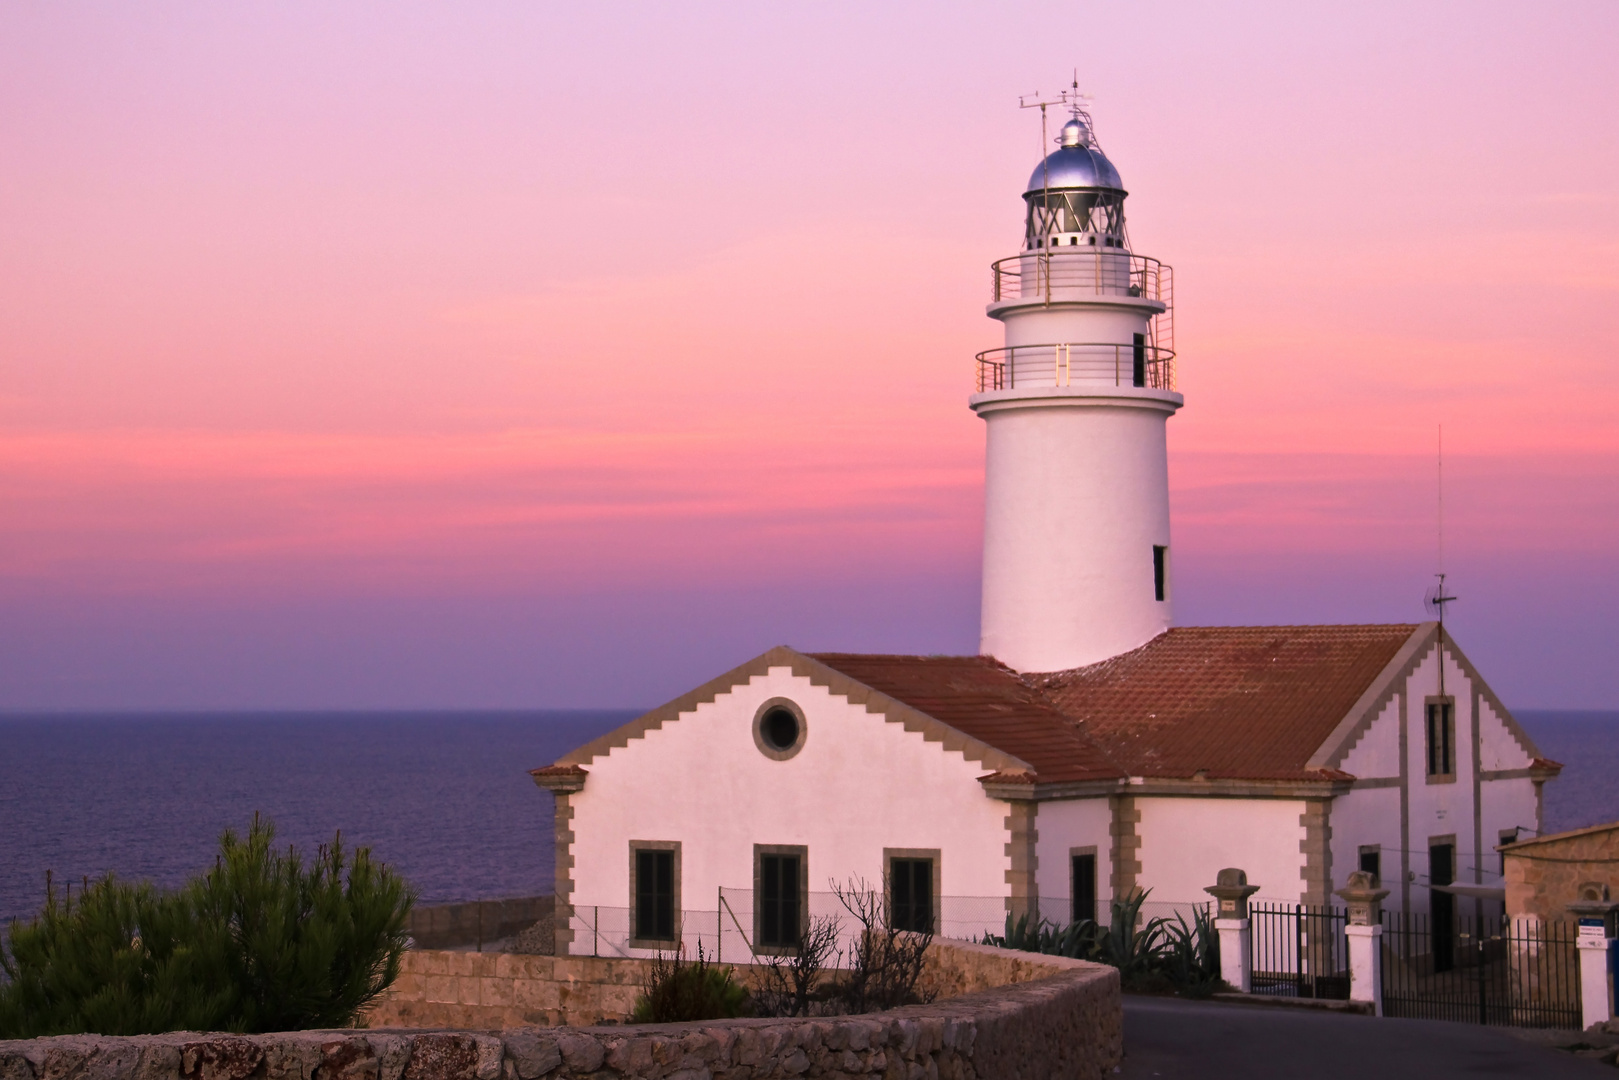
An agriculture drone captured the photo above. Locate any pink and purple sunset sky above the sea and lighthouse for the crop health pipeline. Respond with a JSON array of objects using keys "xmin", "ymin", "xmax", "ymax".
[{"xmin": 0, "ymin": 0, "xmax": 1619, "ymax": 709}]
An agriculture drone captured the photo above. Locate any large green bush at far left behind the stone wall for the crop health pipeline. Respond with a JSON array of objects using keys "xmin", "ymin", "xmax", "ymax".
[{"xmin": 0, "ymin": 816, "xmax": 414, "ymax": 1038}]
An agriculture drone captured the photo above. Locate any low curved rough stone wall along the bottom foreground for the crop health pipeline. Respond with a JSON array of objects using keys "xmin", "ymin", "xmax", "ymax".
[{"xmin": 0, "ymin": 944, "xmax": 1124, "ymax": 1080}]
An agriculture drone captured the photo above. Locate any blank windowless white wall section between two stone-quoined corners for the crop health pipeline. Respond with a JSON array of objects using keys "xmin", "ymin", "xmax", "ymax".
[{"xmin": 1135, "ymin": 797, "xmax": 1305, "ymax": 904}]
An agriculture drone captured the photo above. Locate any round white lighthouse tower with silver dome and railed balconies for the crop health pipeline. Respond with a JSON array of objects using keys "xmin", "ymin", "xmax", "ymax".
[{"xmin": 970, "ymin": 101, "xmax": 1183, "ymax": 672}]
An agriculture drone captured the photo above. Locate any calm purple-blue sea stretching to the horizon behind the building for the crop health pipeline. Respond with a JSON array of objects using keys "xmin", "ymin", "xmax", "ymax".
[{"xmin": 0, "ymin": 709, "xmax": 1619, "ymax": 926}]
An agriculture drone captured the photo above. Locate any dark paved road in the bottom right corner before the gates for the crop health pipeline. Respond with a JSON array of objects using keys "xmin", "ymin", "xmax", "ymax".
[{"xmin": 1120, "ymin": 996, "xmax": 1619, "ymax": 1080}]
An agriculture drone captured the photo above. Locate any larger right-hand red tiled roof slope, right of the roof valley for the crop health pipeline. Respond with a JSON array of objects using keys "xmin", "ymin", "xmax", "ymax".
[{"xmin": 1028, "ymin": 623, "xmax": 1421, "ymax": 780}]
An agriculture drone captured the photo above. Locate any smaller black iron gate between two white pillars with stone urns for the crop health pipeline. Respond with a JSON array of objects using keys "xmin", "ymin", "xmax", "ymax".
[{"xmin": 1248, "ymin": 904, "xmax": 1349, "ymax": 1001}]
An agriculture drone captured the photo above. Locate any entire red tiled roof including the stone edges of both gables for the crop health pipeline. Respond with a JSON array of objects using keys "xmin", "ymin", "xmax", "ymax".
[{"xmin": 534, "ymin": 623, "xmax": 1559, "ymax": 790}]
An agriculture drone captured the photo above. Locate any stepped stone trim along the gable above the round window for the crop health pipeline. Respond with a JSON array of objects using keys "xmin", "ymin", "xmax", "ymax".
[{"xmin": 550, "ymin": 644, "xmax": 1033, "ymax": 779}]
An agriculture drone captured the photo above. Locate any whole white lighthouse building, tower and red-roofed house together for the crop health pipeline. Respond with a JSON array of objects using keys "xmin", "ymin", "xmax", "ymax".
[{"xmin": 534, "ymin": 110, "xmax": 1559, "ymax": 952}]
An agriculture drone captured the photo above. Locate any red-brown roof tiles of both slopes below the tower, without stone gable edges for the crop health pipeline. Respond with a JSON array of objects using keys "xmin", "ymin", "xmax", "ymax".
[{"xmin": 814, "ymin": 623, "xmax": 1418, "ymax": 784}]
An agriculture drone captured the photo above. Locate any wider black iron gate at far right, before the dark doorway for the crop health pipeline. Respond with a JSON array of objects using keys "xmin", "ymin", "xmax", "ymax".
[{"xmin": 1383, "ymin": 912, "xmax": 1580, "ymax": 1030}]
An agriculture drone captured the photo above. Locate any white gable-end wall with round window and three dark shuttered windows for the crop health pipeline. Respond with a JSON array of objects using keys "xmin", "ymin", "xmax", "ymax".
[{"xmin": 572, "ymin": 667, "xmax": 1010, "ymax": 952}]
